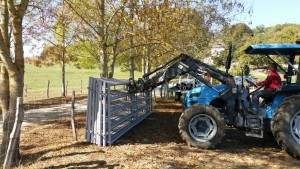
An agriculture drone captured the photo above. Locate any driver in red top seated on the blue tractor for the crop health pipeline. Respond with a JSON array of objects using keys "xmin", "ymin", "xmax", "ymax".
[{"xmin": 252, "ymin": 63, "xmax": 281, "ymax": 111}]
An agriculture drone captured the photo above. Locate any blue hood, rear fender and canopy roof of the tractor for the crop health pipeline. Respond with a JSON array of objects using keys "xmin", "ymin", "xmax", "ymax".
[{"xmin": 184, "ymin": 44, "xmax": 300, "ymax": 119}]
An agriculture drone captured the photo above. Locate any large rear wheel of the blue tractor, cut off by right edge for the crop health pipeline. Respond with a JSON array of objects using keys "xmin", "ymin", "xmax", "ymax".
[{"xmin": 271, "ymin": 97, "xmax": 300, "ymax": 159}]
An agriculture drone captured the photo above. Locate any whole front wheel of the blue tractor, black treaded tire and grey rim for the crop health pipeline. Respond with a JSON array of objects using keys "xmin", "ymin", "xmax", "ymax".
[{"xmin": 178, "ymin": 104, "xmax": 226, "ymax": 149}]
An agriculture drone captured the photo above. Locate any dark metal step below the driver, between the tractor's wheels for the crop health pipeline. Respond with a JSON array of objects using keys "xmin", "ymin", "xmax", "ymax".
[{"xmin": 245, "ymin": 115, "xmax": 264, "ymax": 138}]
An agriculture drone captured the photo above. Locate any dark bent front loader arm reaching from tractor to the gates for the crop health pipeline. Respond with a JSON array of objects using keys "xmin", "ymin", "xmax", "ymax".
[{"xmin": 129, "ymin": 54, "xmax": 236, "ymax": 96}]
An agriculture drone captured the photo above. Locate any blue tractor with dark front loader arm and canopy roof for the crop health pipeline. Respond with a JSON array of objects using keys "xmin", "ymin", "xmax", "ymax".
[{"xmin": 129, "ymin": 40, "xmax": 300, "ymax": 159}]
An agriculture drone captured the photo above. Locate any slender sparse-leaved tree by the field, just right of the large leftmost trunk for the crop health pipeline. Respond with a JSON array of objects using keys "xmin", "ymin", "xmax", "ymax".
[{"xmin": 25, "ymin": 0, "xmax": 78, "ymax": 97}]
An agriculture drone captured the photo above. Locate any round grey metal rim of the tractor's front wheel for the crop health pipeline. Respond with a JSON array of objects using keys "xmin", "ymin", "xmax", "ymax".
[{"xmin": 189, "ymin": 114, "xmax": 217, "ymax": 142}]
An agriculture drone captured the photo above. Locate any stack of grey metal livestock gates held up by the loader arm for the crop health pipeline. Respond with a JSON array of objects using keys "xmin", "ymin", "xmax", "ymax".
[{"xmin": 85, "ymin": 77, "xmax": 152, "ymax": 146}]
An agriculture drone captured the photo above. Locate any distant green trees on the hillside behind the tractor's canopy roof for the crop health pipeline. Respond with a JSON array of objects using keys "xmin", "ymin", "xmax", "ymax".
[{"xmin": 214, "ymin": 24, "xmax": 300, "ymax": 68}]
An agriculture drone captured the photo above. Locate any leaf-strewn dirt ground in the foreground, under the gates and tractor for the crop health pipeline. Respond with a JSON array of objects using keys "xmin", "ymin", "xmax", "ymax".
[{"xmin": 11, "ymin": 100, "xmax": 300, "ymax": 169}]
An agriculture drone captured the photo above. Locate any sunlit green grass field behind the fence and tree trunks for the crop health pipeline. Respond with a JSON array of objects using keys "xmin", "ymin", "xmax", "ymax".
[{"xmin": 24, "ymin": 64, "xmax": 142, "ymax": 102}]
